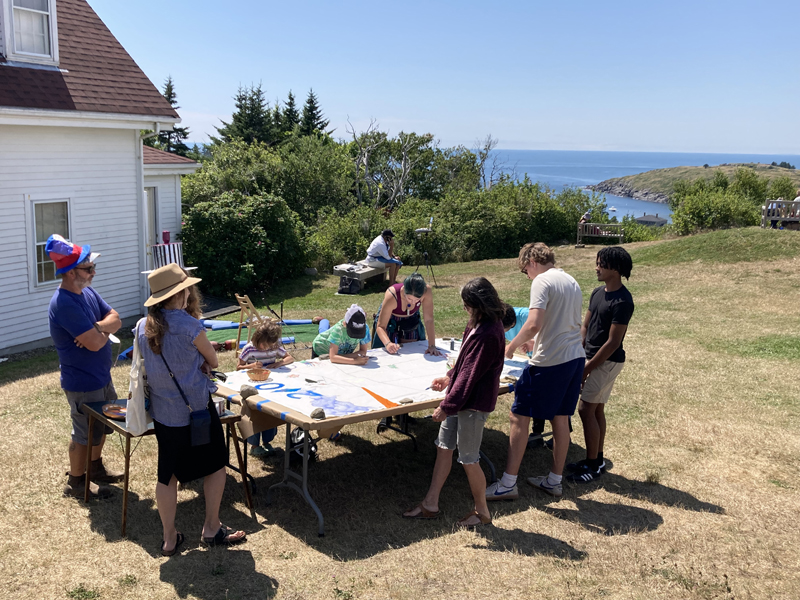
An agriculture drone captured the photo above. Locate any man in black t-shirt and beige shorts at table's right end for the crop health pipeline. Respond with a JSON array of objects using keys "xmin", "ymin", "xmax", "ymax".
[{"xmin": 567, "ymin": 246, "xmax": 633, "ymax": 483}]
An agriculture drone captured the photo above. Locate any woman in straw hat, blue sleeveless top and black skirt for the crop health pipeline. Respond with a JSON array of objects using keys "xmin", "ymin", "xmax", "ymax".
[{"xmin": 135, "ymin": 263, "xmax": 246, "ymax": 556}]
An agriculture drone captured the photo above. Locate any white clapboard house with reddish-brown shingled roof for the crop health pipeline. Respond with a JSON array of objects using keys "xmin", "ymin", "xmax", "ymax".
[{"xmin": 0, "ymin": 0, "xmax": 198, "ymax": 355}]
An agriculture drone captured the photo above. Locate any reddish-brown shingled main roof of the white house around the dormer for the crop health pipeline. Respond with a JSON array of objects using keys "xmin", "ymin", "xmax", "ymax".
[{"xmin": 0, "ymin": 0, "xmax": 178, "ymax": 118}]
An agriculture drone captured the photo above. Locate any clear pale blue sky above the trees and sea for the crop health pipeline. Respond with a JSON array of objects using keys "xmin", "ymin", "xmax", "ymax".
[{"xmin": 89, "ymin": 0, "xmax": 800, "ymax": 154}]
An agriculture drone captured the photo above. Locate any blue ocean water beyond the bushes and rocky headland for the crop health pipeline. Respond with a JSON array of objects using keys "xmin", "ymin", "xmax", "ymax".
[{"xmin": 495, "ymin": 150, "xmax": 800, "ymax": 220}]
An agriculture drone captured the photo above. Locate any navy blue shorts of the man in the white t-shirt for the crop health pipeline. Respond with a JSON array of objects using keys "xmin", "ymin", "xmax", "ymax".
[{"xmin": 511, "ymin": 358, "xmax": 586, "ymax": 421}]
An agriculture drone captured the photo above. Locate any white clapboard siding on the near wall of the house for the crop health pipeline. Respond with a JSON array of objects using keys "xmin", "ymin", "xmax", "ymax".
[{"xmin": 0, "ymin": 125, "xmax": 142, "ymax": 354}]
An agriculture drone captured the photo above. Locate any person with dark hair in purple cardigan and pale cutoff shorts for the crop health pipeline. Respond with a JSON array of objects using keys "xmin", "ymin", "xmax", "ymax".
[{"xmin": 403, "ymin": 277, "xmax": 505, "ymax": 529}]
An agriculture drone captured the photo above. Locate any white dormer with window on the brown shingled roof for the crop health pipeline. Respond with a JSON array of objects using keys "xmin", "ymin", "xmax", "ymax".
[{"xmin": 0, "ymin": 0, "xmax": 58, "ymax": 67}]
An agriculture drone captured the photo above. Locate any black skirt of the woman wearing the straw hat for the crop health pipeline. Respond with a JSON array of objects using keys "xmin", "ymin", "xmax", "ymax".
[{"xmin": 153, "ymin": 399, "xmax": 228, "ymax": 485}]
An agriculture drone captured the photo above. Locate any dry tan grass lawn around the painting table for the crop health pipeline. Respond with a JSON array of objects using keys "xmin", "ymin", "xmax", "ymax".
[{"xmin": 0, "ymin": 227, "xmax": 800, "ymax": 600}]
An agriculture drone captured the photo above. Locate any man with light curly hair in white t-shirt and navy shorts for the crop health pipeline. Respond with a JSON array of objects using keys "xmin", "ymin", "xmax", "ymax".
[{"xmin": 486, "ymin": 243, "xmax": 586, "ymax": 500}]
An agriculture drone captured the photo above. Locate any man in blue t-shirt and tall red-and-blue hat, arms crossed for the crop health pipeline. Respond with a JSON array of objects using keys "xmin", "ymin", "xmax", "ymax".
[{"xmin": 45, "ymin": 235, "xmax": 122, "ymax": 498}]
